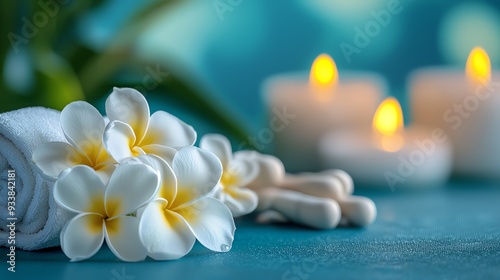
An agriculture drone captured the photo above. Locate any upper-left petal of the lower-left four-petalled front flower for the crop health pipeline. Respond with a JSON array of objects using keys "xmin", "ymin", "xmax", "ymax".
[{"xmin": 54, "ymin": 165, "xmax": 105, "ymax": 215}]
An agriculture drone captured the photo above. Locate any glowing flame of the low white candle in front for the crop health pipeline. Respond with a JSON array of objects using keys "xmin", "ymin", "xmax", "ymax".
[{"xmin": 373, "ymin": 97, "xmax": 403, "ymax": 152}]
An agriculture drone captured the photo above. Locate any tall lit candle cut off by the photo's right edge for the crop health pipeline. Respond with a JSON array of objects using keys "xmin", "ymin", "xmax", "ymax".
[{"xmin": 410, "ymin": 47, "xmax": 500, "ymax": 179}]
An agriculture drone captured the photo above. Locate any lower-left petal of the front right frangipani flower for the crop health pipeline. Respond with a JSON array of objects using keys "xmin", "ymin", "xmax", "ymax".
[{"xmin": 139, "ymin": 200, "xmax": 196, "ymax": 260}]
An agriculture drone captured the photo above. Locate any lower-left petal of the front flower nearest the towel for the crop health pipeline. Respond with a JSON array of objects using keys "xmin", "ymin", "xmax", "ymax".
[{"xmin": 61, "ymin": 213, "xmax": 104, "ymax": 261}]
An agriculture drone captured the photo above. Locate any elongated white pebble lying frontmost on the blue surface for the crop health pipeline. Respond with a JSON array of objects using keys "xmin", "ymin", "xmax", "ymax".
[{"xmin": 257, "ymin": 188, "xmax": 342, "ymax": 229}]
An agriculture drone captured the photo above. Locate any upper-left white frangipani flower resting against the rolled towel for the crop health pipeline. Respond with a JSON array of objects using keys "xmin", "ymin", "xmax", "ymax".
[{"xmin": 32, "ymin": 101, "xmax": 116, "ymax": 182}]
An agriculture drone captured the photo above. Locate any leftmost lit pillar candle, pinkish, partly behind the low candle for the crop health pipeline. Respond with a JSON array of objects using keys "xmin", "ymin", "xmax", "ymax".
[{"xmin": 264, "ymin": 54, "xmax": 386, "ymax": 172}]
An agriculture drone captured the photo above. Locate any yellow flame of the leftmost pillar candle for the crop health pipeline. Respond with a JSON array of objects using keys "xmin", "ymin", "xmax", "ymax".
[{"xmin": 309, "ymin": 54, "xmax": 339, "ymax": 97}]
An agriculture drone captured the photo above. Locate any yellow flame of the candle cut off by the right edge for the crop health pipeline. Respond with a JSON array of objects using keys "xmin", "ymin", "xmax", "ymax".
[{"xmin": 465, "ymin": 47, "xmax": 491, "ymax": 85}]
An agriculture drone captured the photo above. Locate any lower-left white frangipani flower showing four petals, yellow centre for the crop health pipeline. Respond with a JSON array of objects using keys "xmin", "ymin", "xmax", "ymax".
[{"xmin": 54, "ymin": 163, "xmax": 159, "ymax": 261}]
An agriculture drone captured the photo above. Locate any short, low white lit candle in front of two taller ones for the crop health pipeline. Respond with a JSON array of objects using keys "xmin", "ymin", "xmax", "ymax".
[{"xmin": 319, "ymin": 98, "xmax": 452, "ymax": 189}]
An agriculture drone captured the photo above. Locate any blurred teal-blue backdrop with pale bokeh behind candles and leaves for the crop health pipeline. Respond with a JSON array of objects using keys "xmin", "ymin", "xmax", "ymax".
[{"xmin": 2, "ymin": 0, "xmax": 500, "ymax": 138}]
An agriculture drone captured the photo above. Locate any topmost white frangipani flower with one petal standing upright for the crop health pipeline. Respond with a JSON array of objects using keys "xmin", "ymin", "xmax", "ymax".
[{"xmin": 104, "ymin": 88, "xmax": 196, "ymax": 162}]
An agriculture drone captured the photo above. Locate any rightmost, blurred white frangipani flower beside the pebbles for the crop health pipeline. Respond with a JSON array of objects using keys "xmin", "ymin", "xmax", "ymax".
[{"xmin": 200, "ymin": 134, "xmax": 258, "ymax": 217}]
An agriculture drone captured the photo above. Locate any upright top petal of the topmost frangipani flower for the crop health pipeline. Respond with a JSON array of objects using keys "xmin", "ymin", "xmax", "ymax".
[{"xmin": 106, "ymin": 87, "xmax": 149, "ymax": 143}]
